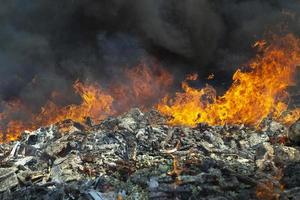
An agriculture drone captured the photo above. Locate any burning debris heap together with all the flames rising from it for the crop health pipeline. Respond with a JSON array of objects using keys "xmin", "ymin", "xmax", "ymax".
[{"xmin": 0, "ymin": 34, "xmax": 300, "ymax": 200}]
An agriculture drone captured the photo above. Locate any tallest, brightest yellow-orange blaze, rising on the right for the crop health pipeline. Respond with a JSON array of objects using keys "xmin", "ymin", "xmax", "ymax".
[{"xmin": 157, "ymin": 34, "xmax": 300, "ymax": 126}]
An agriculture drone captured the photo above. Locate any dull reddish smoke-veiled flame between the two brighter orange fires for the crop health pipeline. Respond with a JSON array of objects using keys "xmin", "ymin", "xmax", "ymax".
[{"xmin": 109, "ymin": 64, "xmax": 173, "ymax": 113}]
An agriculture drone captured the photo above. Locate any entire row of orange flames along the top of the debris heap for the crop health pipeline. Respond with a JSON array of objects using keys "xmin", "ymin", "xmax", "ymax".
[{"xmin": 0, "ymin": 34, "xmax": 300, "ymax": 141}]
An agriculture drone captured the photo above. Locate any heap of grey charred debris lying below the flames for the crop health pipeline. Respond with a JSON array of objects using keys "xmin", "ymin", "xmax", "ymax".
[{"xmin": 0, "ymin": 109, "xmax": 300, "ymax": 200}]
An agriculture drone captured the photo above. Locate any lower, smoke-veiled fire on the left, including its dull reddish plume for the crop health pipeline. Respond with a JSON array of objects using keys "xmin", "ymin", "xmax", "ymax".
[{"xmin": 0, "ymin": 64, "xmax": 172, "ymax": 142}]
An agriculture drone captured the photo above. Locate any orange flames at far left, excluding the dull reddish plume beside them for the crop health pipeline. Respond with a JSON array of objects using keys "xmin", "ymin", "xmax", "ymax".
[{"xmin": 0, "ymin": 81, "xmax": 113, "ymax": 141}]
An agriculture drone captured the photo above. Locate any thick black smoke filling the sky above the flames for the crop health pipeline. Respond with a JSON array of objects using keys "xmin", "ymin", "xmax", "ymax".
[{"xmin": 0, "ymin": 0, "xmax": 300, "ymax": 107}]
